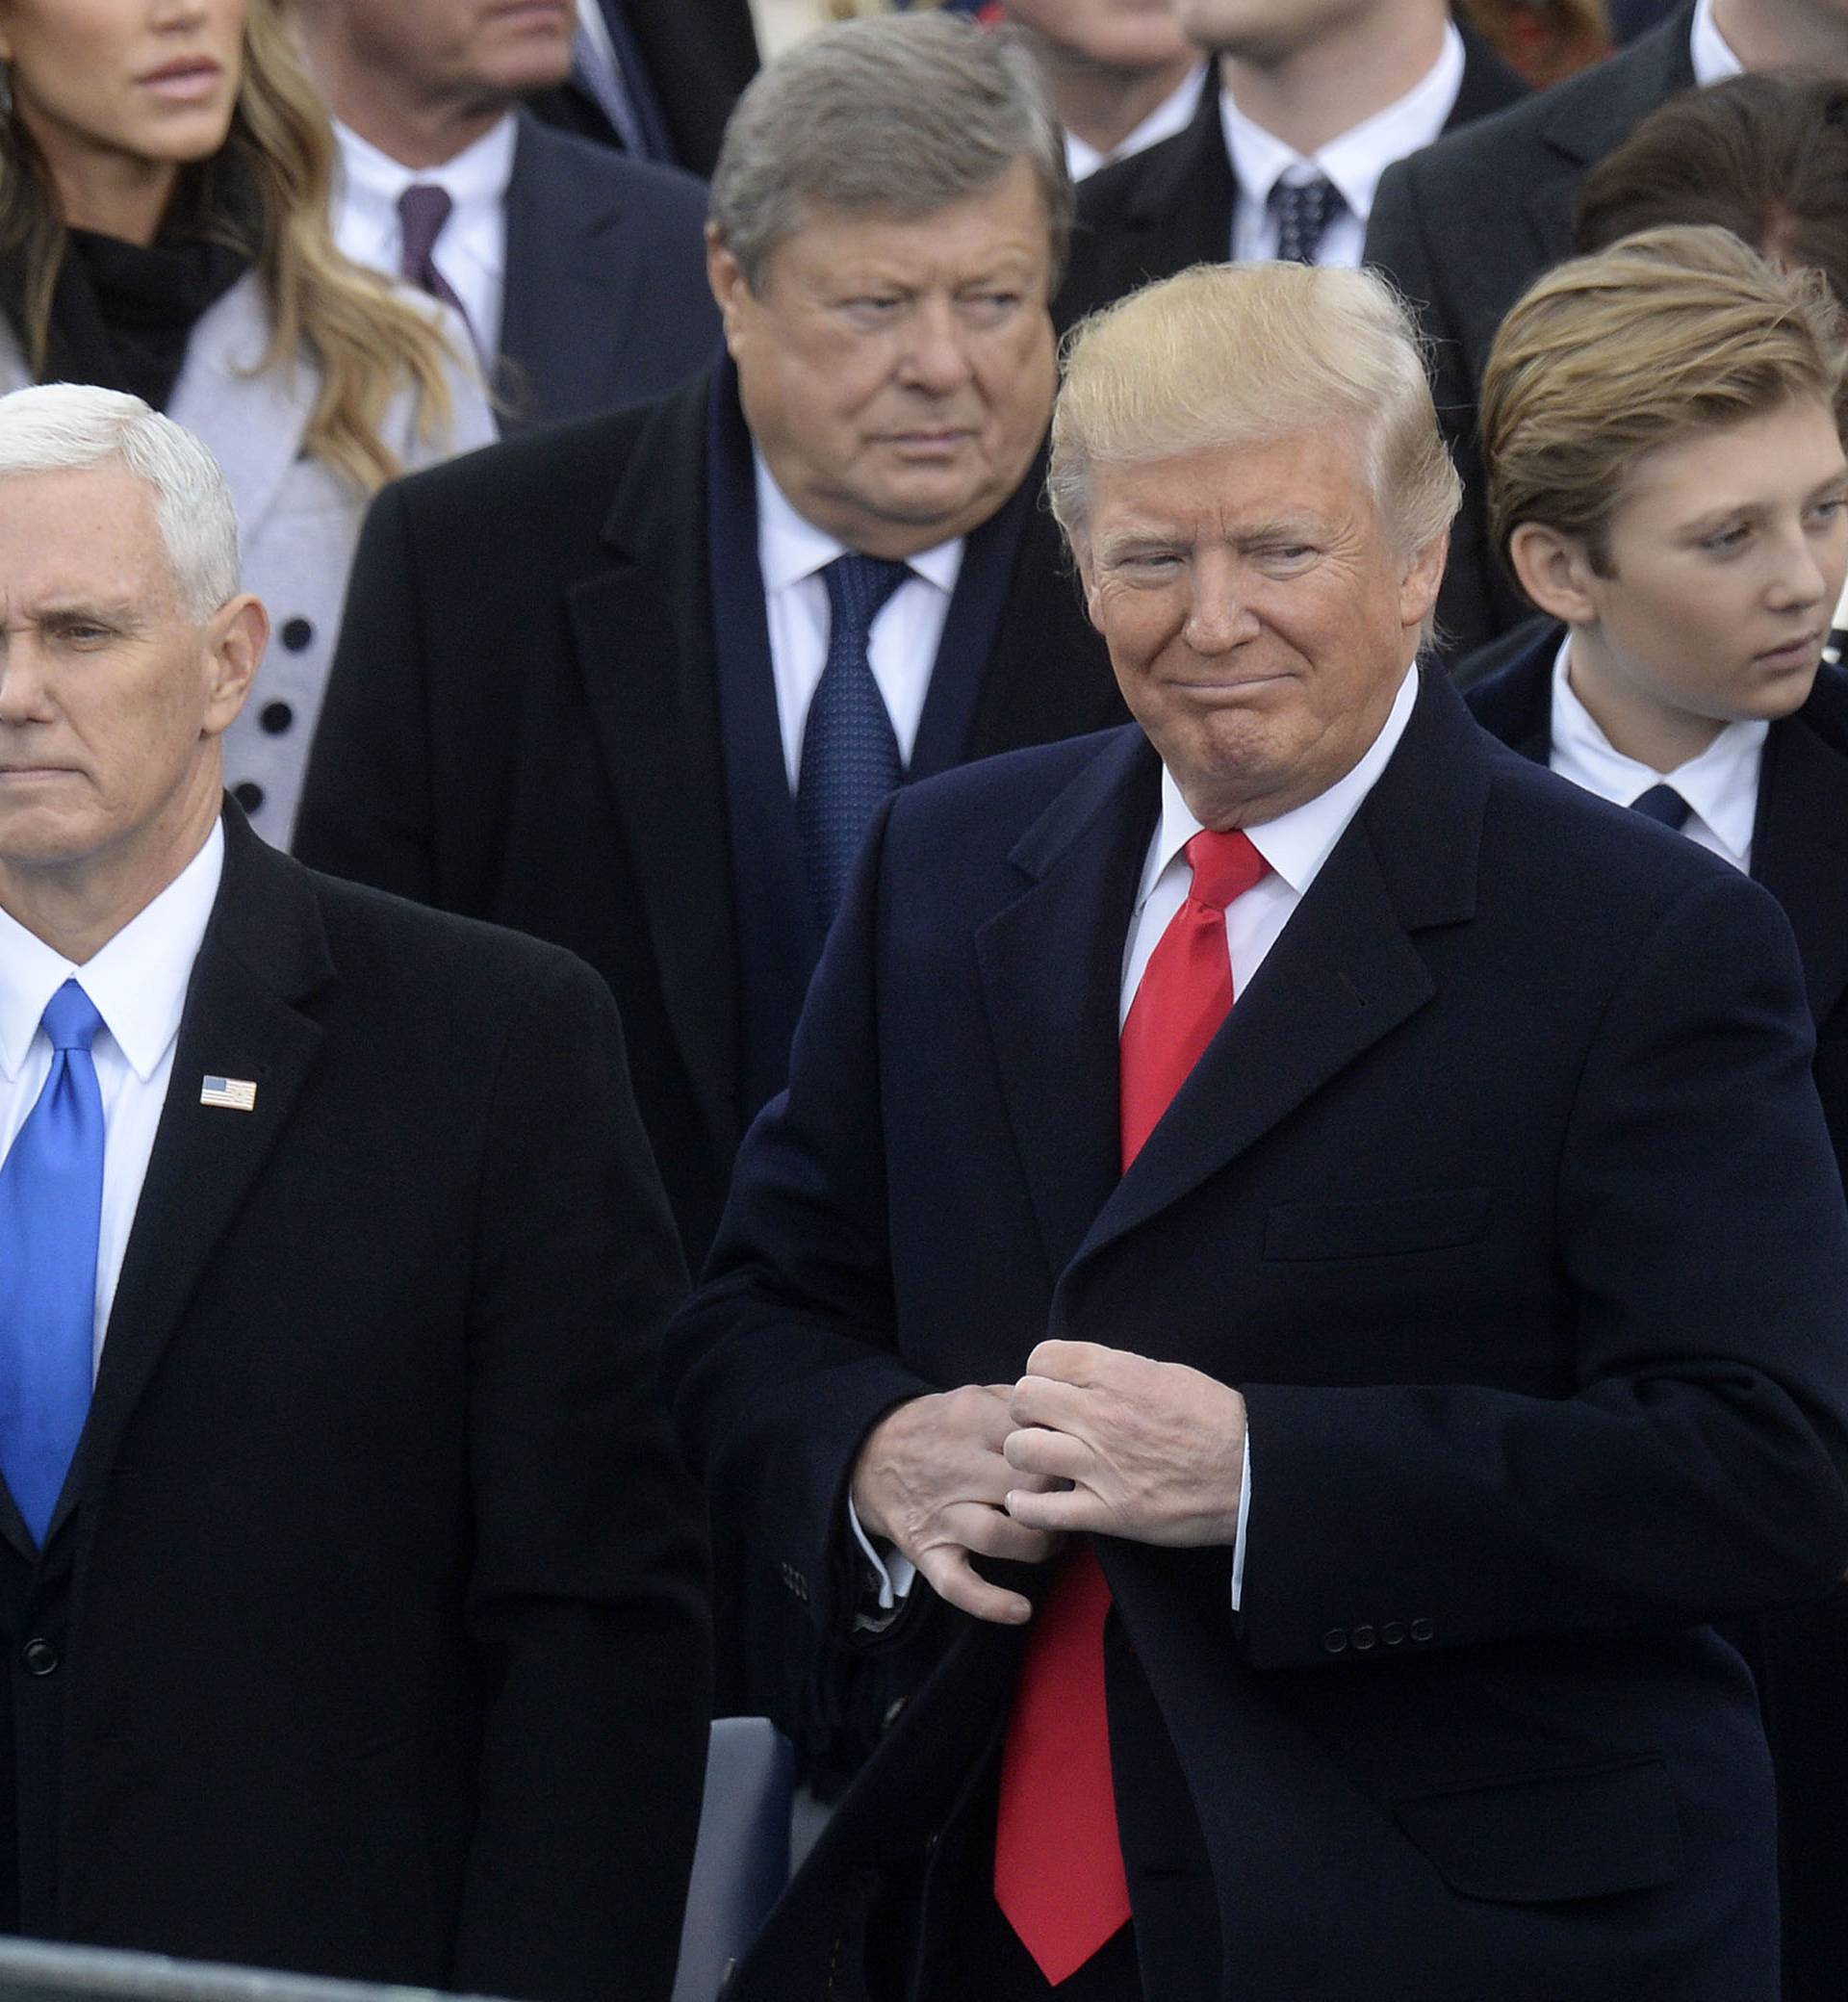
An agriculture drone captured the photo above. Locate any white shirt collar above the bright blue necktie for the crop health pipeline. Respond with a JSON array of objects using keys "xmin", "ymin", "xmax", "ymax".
[{"xmin": 0, "ymin": 821, "xmax": 224, "ymax": 1083}]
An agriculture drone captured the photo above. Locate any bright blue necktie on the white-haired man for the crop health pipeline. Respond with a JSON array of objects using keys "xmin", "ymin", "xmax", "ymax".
[{"xmin": 0, "ymin": 981, "xmax": 102, "ymax": 1544}]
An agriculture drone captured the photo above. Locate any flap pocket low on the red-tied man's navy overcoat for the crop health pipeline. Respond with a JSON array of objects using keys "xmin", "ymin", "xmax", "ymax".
[{"xmin": 1394, "ymin": 1758, "xmax": 1681, "ymax": 1904}]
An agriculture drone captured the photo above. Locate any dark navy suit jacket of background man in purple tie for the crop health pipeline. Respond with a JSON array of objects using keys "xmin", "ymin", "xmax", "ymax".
[{"xmin": 499, "ymin": 112, "xmax": 719, "ymax": 436}]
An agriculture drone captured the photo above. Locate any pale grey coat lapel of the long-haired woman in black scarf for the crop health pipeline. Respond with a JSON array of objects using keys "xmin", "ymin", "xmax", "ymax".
[{"xmin": 167, "ymin": 272, "xmax": 306, "ymax": 549}]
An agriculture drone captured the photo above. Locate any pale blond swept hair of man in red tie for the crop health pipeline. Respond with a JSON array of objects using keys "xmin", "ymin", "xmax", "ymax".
[{"xmin": 1047, "ymin": 265, "xmax": 1462, "ymax": 554}]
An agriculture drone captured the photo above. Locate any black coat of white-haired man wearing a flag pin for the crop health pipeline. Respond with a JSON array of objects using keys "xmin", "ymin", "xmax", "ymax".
[{"xmin": 0, "ymin": 807, "xmax": 708, "ymax": 2002}]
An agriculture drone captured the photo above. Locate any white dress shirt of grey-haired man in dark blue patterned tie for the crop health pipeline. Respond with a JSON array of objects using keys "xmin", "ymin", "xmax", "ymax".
[{"xmin": 755, "ymin": 452, "xmax": 963, "ymax": 793}]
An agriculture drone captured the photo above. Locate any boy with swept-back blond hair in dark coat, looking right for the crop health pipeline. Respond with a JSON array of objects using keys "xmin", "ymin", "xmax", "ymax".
[{"xmin": 1470, "ymin": 222, "xmax": 1848, "ymax": 2002}]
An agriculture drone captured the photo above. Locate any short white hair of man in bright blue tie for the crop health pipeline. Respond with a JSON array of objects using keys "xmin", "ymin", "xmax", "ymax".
[{"xmin": 0, "ymin": 382, "xmax": 239, "ymax": 625}]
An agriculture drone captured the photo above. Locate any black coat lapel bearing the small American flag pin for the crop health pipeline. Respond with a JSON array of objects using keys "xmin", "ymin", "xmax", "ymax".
[{"xmin": 48, "ymin": 808, "xmax": 334, "ymax": 1542}]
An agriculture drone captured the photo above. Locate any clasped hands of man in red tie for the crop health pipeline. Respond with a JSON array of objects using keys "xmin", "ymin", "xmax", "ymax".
[{"xmin": 853, "ymin": 1342, "xmax": 1245, "ymax": 1626}]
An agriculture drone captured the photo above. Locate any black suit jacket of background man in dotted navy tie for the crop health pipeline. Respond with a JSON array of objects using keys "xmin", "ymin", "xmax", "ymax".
[{"xmin": 1055, "ymin": 28, "xmax": 1527, "ymax": 326}]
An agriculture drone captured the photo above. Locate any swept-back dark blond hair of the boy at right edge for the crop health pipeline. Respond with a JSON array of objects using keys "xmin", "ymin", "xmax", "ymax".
[{"xmin": 1481, "ymin": 226, "xmax": 1848, "ymax": 575}]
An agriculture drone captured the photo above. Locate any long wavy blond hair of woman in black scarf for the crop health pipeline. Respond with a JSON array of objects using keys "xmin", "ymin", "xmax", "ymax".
[{"xmin": 0, "ymin": 0, "xmax": 456, "ymax": 495}]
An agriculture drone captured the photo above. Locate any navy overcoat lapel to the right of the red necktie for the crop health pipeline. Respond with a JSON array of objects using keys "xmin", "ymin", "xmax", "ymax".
[{"xmin": 1067, "ymin": 675, "xmax": 1488, "ymax": 1277}]
